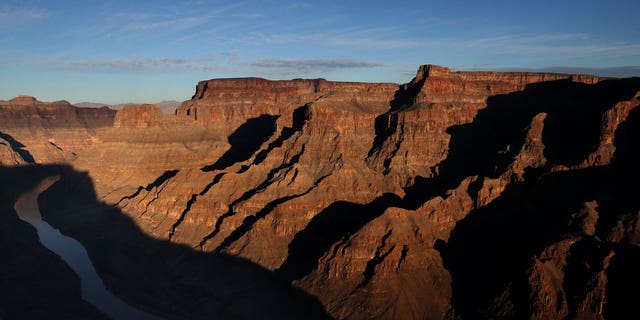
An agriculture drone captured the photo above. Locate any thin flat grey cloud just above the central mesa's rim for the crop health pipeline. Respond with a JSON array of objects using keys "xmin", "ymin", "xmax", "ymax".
[{"xmin": 250, "ymin": 59, "xmax": 382, "ymax": 74}]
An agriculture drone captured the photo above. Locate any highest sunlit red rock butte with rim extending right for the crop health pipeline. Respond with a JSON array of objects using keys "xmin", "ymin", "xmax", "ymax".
[{"xmin": 367, "ymin": 65, "xmax": 604, "ymax": 183}]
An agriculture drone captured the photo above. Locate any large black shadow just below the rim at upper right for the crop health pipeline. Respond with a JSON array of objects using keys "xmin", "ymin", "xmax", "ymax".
[{"xmin": 402, "ymin": 78, "xmax": 640, "ymax": 209}]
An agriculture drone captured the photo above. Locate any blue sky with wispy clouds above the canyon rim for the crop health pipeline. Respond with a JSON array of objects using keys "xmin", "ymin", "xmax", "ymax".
[{"xmin": 0, "ymin": 0, "xmax": 640, "ymax": 104}]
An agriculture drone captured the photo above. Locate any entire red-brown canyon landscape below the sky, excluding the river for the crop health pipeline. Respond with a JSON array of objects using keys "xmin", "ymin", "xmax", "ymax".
[{"xmin": 0, "ymin": 65, "xmax": 640, "ymax": 319}]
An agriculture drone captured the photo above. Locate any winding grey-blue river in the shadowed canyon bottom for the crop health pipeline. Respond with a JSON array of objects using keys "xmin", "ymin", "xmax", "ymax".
[{"xmin": 14, "ymin": 177, "xmax": 161, "ymax": 319}]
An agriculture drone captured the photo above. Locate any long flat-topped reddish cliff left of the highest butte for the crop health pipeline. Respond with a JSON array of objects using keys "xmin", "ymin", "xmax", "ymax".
[{"xmin": 176, "ymin": 78, "xmax": 397, "ymax": 133}]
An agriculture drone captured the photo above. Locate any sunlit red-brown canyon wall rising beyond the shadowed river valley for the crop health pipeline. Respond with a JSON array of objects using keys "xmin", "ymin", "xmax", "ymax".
[{"xmin": 0, "ymin": 65, "xmax": 640, "ymax": 319}]
